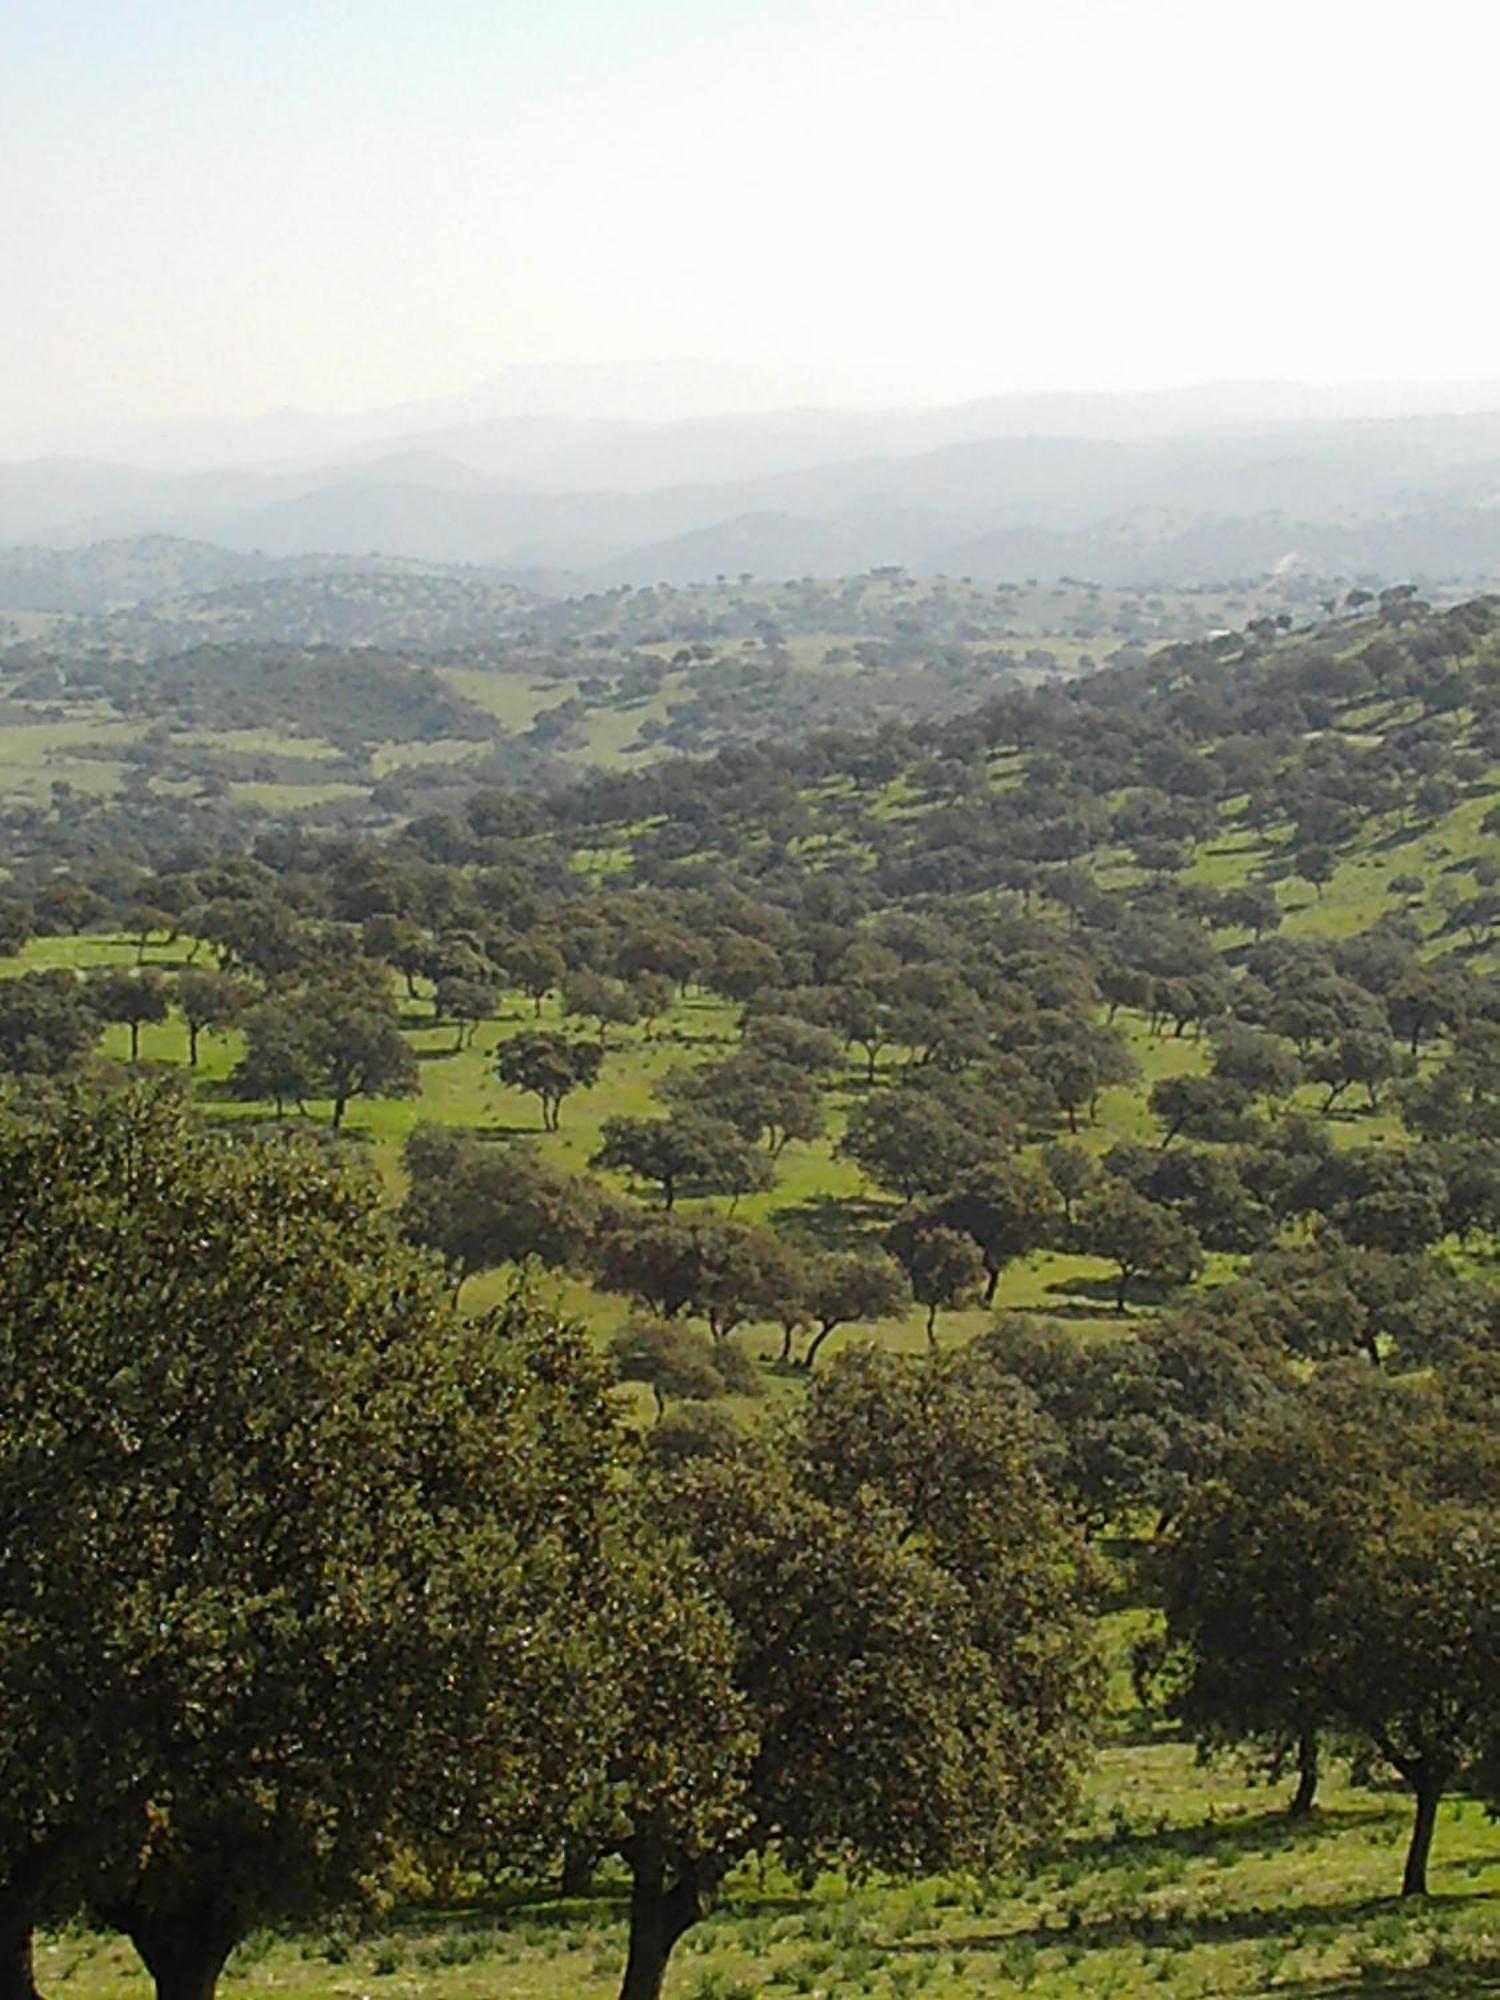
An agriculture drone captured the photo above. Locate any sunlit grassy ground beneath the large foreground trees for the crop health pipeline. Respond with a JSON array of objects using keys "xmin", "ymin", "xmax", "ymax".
[{"xmin": 38, "ymin": 1614, "xmax": 1500, "ymax": 2000}]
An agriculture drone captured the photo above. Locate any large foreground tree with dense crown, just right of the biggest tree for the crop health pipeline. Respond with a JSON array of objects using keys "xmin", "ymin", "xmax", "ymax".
[{"xmin": 596, "ymin": 1354, "xmax": 1096, "ymax": 2000}]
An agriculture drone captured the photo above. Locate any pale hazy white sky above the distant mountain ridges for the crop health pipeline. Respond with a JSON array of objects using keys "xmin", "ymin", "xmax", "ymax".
[{"xmin": 0, "ymin": 0, "xmax": 1500, "ymax": 440}]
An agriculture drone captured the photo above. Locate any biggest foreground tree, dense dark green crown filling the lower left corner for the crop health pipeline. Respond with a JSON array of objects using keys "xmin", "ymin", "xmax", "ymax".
[{"xmin": 0, "ymin": 1092, "xmax": 612, "ymax": 2000}]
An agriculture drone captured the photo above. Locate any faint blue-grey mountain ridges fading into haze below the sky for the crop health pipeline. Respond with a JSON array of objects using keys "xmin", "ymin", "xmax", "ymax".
[{"xmin": 0, "ymin": 364, "xmax": 1500, "ymax": 588}]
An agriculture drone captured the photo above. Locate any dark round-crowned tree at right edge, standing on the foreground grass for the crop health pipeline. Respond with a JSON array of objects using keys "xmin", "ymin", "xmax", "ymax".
[{"xmin": 1158, "ymin": 1388, "xmax": 1500, "ymax": 1896}]
